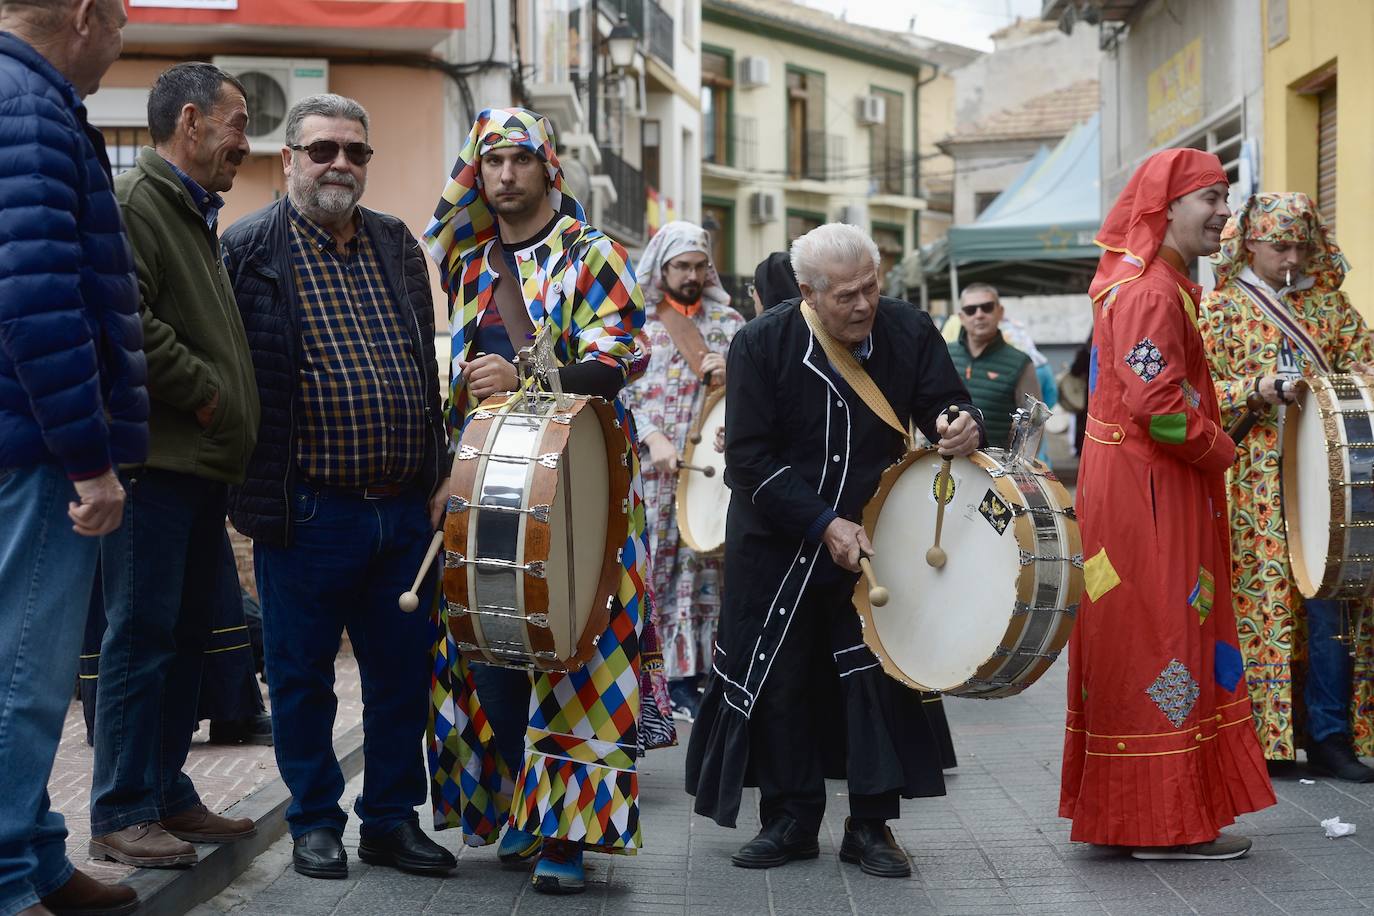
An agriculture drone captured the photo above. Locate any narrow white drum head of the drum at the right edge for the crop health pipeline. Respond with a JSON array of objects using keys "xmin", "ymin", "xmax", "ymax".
[{"xmin": 1283, "ymin": 390, "xmax": 1331, "ymax": 597}]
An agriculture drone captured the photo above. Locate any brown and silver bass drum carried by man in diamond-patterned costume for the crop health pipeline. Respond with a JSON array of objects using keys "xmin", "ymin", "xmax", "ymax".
[{"xmin": 444, "ymin": 394, "xmax": 629, "ymax": 672}]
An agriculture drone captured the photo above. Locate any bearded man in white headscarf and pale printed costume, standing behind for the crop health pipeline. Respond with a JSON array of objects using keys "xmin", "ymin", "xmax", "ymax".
[{"xmin": 625, "ymin": 221, "xmax": 745, "ymax": 720}]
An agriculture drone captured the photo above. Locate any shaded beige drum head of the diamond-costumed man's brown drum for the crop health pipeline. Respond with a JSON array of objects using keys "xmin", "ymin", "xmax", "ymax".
[{"xmin": 545, "ymin": 405, "xmax": 611, "ymax": 658}]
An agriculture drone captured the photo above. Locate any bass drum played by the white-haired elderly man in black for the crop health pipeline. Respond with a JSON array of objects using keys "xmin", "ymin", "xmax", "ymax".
[{"xmin": 855, "ymin": 449, "xmax": 1083, "ymax": 699}]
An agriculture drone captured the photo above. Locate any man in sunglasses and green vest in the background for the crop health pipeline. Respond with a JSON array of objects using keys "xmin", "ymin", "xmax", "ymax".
[{"xmin": 949, "ymin": 283, "xmax": 1040, "ymax": 448}]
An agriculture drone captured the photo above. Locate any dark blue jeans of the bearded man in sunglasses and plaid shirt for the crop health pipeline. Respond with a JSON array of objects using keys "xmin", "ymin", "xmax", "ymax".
[{"xmin": 253, "ymin": 485, "xmax": 434, "ymax": 836}]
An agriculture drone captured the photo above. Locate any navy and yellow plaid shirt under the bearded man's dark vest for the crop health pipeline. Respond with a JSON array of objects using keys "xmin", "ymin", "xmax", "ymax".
[{"xmin": 290, "ymin": 200, "xmax": 426, "ymax": 486}]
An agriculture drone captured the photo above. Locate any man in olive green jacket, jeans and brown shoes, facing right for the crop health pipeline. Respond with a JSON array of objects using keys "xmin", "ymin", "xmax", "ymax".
[{"xmin": 91, "ymin": 63, "xmax": 258, "ymax": 867}]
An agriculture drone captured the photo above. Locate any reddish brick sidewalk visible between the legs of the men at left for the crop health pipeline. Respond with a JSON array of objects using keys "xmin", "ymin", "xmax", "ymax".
[{"xmin": 48, "ymin": 643, "xmax": 363, "ymax": 880}]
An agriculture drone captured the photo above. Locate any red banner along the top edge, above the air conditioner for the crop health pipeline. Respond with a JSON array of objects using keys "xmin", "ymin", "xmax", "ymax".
[{"xmin": 129, "ymin": 0, "xmax": 464, "ymax": 29}]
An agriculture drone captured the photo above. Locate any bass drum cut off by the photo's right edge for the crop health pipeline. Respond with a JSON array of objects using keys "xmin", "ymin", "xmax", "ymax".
[{"xmin": 1282, "ymin": 375, "xmax": 1374, "ymax": 600}]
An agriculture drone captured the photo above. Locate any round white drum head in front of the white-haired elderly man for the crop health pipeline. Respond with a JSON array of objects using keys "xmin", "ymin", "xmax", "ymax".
[{"xmin": 872, "ymin": 452, "xmax": 1021, "ymax": 691}]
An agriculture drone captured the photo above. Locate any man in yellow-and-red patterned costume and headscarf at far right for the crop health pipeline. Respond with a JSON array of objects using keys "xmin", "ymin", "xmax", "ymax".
[{"xmin": 1201, "ymin": 194, "xmax": 1374, "ymax": 783}]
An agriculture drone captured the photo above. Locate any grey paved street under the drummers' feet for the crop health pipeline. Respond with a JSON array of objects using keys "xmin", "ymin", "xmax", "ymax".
[{"xmin": 194, "ymin": 662, "xmax": 1374, "ymax": 916}]
